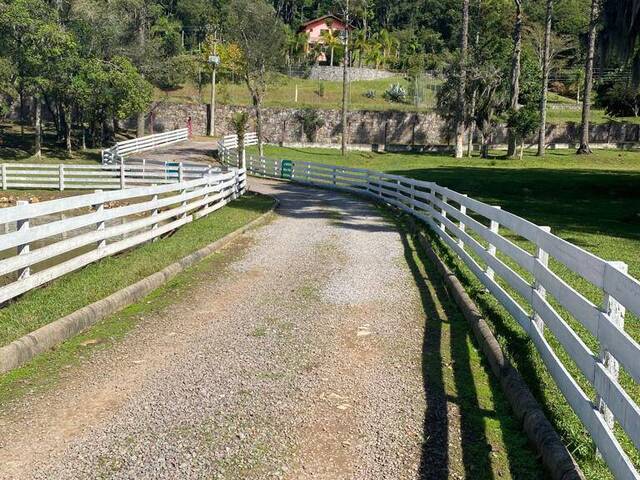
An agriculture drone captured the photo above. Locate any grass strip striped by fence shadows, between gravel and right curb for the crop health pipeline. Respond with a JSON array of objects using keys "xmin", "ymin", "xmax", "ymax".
[{"xmin": 396, "ymin": 211, "xmax": 544, "ymax": 479}]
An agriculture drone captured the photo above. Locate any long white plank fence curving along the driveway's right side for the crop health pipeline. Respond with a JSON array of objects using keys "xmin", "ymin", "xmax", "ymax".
[{"xmin": 247, "ymin": 156, "xmax": 640, "ymax": 479}]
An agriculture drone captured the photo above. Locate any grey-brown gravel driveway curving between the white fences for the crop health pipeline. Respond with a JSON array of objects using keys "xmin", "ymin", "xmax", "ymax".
[{"xmin": 0, "ymin": 180, "xmax": 510, "ymax": 479}]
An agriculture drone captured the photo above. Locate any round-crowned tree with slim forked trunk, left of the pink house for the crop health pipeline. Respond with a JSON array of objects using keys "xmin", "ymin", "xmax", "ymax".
[{"xmin": 225, "ymin": 0, "xmax": 285, "ymax": 156}]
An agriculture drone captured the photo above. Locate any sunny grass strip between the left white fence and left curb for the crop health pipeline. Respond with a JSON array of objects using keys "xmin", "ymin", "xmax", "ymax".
[{"xmin": 0, "ymin": 195, "xmax": 273, "ymax": 345}]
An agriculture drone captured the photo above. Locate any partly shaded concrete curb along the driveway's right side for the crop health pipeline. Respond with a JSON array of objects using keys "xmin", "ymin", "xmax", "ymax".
[{"xmin": 408, "ymin": 217, "xmax": 585, "ymax": 480}]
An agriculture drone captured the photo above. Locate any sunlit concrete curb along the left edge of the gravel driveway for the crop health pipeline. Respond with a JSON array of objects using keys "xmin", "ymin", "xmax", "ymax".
[{"xmin": 0, "ymin": 195, "xmax": 279, "ymax": 374}]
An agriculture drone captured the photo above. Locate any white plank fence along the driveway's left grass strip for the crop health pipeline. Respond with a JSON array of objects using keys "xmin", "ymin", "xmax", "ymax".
[{"xmin": 0, "ymin": 170, "xmax": 246, "ymax": 304}]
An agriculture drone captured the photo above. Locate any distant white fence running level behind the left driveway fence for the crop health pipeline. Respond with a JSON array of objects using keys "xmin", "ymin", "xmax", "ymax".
[{"xmin": 0, "ymin": 160, "xmax": 220, "ymax": 191}]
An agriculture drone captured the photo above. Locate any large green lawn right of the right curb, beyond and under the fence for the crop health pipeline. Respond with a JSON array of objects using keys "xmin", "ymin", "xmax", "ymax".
[{"xmin": 258, "ymin": 147, "xmax": 640, "ymax": 479}]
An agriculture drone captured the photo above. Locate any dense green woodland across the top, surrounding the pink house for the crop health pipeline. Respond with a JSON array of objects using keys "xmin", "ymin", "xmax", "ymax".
[{"xmin": 0, "ymin": 0, "xmax": 640, "ymax": 158}]
